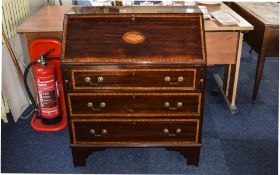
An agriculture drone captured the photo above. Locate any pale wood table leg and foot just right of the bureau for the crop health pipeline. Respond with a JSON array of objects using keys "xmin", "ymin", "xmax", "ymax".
[{"xmin": 213, "ymin": 32, "xmax": 243, "ymax": 114}]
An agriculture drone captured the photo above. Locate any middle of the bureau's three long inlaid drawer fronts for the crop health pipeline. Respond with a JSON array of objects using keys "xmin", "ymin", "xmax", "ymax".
[{"xmin": 68, "ymin": 93, "xmax": 201, "ymax": 117}]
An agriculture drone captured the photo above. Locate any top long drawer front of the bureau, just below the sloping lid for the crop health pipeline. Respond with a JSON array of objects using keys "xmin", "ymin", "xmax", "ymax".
[{"xmin": 71, "ymin": 68, "xmax": 203, "ymax": 90}]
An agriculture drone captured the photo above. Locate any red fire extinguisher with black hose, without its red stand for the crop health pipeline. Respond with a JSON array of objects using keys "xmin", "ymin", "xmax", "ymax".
[{"xmin": 24, "ymin": 49, "xmax": 62, "ymax": 125}]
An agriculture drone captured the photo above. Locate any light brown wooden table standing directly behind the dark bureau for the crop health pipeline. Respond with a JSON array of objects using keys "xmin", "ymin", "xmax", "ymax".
[{"xmin": 17, "ymin": 3, "xmax": 253, "ymax": 113}]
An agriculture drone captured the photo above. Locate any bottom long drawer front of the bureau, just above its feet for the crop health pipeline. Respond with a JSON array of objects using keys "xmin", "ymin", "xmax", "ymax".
[{"xmin": 71, "ymin": 119, "xmax": 200, "ymax": 144}]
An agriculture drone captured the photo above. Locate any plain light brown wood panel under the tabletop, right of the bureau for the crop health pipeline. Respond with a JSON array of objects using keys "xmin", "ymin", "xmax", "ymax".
[{"xmin": 205, "ymin": 32, "xmax": 239, "ymax": 65}]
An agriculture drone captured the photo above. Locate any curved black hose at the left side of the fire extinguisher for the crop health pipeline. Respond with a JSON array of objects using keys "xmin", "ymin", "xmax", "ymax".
[{"xmin": 23, "ymin": 58, "xmax": 59, "ymax": 118}]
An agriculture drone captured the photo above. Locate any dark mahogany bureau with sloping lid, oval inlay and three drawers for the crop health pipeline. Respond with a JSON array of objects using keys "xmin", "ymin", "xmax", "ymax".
[{"xmin": 61, "ymin": 7, "xmax": 206, "ymax": 166}]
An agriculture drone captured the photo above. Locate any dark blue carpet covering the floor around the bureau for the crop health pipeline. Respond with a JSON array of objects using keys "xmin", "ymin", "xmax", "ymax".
[{"xmin": 1, "ymin": 43, "xmax": 279, "ymax": 175}]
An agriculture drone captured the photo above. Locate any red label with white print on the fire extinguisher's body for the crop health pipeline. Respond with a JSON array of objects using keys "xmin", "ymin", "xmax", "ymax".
[{"xmin": 37, "ymin": 76, "xmax": 59, "ymax": 118}]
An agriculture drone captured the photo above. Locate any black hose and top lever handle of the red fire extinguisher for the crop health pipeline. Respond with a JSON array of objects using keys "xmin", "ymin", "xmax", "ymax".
[{"xmin": 23, "ymin": 49, "xmax": 60, "ymax": 118}]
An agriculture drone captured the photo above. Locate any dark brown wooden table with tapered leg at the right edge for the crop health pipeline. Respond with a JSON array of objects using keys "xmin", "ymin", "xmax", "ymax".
[{"xmin": 231, "ymin": 2, "xmax": 279, "ymax": 101}]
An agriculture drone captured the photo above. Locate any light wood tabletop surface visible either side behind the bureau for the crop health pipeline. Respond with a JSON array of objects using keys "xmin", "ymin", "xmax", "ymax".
[{"xmin": 17, "ymin": 3, "xmax": 253, "ymax": 33}]
